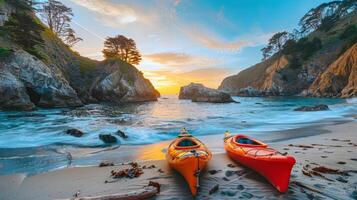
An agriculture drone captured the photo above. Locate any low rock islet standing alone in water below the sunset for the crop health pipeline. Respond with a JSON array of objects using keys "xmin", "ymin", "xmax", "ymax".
[{"xmin": 179, "ymin": 83, "xmax": 234, "ymax": 103}]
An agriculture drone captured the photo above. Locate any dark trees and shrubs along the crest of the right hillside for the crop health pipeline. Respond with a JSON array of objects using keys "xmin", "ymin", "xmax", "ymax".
[{"xmin": 261, "ymin": 0, "xmax": 357, "ymax": 65}]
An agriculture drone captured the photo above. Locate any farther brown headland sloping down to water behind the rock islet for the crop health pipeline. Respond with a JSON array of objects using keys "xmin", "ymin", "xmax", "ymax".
[{"xmin": 218, "ymin": 55, "xmax": 305, "ymax": 96}]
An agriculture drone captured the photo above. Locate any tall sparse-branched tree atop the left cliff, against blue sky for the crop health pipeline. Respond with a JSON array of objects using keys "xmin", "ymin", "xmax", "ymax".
[{"xmin": 40, "ymin": 0, "xmax": 82, "ymax": 47}]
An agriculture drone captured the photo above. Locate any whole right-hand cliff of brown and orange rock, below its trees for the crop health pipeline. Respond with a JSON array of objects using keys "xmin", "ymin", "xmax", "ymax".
[{"xmin": 219, "ymin": 13, "xmax": 357, "ymax": 97}]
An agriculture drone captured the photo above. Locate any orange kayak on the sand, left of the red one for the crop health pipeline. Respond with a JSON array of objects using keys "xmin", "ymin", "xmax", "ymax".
[{"xmin": 166, "ymin": 131, "xmax": 212, "ymax": 196}]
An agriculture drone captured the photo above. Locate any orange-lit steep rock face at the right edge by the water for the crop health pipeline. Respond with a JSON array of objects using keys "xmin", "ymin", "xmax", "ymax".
[{"xmin": 308, "ymin": 43, "xmax": 357, "ymax": 97}]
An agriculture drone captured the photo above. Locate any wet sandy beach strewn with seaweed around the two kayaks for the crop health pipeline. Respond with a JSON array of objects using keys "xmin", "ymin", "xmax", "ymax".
[{"xmin": 0, "ymin": 121, "xmax": 357, "ymax": 200}]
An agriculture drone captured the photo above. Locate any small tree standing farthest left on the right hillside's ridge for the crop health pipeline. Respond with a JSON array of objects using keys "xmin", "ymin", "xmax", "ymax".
[{"xmin": 261, "ymin": 31, "xmax": 291, "ymax": 60}]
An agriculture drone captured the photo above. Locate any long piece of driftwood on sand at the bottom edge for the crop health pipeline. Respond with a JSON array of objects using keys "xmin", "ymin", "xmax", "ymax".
[{"xmin": 70, "ymin": 186, "xmax": 158, "ymax": 200}]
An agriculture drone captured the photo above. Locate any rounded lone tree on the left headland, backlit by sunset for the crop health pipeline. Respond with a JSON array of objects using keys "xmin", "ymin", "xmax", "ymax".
[{"xmin": 102, "ymin": 35, "xmax": 141, "ymax": 65}]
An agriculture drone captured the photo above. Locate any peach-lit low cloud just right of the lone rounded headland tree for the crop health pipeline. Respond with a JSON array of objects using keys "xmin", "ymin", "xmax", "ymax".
[{"xmin": 144, "ymin": 52, "xmax": 220, "ymax": 67}]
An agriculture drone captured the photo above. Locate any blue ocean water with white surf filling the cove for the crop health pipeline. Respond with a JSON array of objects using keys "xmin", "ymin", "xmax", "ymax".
[{"xmin": 0, "ymin": 96, "xmax": 357, "ymax": 174}]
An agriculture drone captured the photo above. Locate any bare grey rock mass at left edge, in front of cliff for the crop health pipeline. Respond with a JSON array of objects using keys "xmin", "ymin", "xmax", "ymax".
[{"xmin": 0, "ymin": 50, "xmax": 82, "ymax": 109}]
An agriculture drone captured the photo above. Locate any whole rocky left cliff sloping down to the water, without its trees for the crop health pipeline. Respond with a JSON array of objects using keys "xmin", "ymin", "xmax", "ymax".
[{"xmin": 0, "ymin": 3, "xmax": 159, "ymax": 110}]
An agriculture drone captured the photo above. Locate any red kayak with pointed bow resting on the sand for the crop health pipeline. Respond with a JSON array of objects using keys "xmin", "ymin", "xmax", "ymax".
[{"xmin": 224, "ymin": 133, "xmax": 295, "ymax": 192}]
